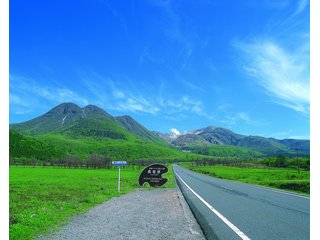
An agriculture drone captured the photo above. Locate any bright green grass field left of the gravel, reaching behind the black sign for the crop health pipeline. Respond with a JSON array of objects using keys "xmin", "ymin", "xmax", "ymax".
[{"xmin": 10, "ymin": 166, "xmax": 175, "ymax": 240}]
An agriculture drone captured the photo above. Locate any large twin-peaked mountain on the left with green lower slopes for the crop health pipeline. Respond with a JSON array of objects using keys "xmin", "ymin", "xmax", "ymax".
[{"xmin": 10, "ymin": 103, "xmax": 199, "ymax": 160}]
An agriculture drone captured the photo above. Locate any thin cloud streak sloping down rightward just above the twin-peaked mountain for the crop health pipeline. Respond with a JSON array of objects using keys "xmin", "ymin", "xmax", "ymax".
[{"xmin": 83, "ymin": 73, "xmax": 212, "ymax": 119}]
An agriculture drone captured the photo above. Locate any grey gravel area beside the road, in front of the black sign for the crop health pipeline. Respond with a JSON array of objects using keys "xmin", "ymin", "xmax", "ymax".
[{"xmin": 38, "ymin": 188, "xmax": 205, "ymax": 240}]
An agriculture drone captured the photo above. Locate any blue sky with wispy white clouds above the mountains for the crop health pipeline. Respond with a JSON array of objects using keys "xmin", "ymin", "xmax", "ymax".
[{"xmin": 9, "ymin": 0, "xmax": 310, "ymax": 138}]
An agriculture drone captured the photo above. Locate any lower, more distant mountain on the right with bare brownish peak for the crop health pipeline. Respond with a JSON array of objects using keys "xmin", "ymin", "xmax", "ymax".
[{"xmin": 157, "ymin": 126, "xmax": 310, "ymax": 155}]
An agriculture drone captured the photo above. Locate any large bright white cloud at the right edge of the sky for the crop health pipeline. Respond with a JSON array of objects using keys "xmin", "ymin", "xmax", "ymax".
[{"xmin": 235, "ymin": 41, "xmax": 310, "ymax": 113}]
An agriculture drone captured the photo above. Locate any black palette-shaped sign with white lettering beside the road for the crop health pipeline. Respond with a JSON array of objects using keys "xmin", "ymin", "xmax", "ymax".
[{"xmin": 139, "ymin": 163, "xmax": 168, "ymax": 187}]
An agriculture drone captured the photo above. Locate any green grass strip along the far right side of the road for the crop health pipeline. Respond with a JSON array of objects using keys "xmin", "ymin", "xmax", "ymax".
[{"xmin": 182, "ymin": 164, "xmax": 310, "ymax": 194}]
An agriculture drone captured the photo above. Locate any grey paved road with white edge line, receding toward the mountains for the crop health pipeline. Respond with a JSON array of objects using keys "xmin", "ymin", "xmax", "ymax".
[{"xmin": 173, "ymin": 165, "xmax": 310, "ymax": 240}]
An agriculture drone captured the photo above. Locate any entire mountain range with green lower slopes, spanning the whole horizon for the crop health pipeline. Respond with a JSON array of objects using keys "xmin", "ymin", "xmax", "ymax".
[{"xmin": 10, "ymin": 103, "xmax": 310, "ymax": 160}]
